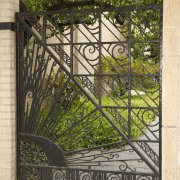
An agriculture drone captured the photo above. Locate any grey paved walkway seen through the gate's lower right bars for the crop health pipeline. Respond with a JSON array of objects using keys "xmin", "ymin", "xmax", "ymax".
[{"xmin": 69, "ymin": 119, "xmax": 159, "ymax": 173}]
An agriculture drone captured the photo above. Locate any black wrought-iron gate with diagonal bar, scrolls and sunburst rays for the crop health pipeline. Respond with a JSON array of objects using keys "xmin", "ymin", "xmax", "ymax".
[{"xmin": 17, "ymin": 5, "xmax": 162, "ymax": 180}]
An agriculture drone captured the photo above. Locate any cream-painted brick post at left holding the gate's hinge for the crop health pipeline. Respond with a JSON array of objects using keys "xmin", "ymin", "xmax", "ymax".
[{"xmin": 0, "ymin": 0, "xmax": 19, "ymax": 180}]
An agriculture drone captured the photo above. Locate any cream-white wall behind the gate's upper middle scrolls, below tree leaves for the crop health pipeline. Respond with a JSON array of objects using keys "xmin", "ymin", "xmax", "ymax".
[{"xmin": 47, "ymin": 15, "xmax": 127, "ymax": 75}]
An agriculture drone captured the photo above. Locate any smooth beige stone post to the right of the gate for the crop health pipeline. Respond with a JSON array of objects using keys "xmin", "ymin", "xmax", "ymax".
[{"xmin": 162, "ymin": 0, "xmax": 180, "ymax": 180}]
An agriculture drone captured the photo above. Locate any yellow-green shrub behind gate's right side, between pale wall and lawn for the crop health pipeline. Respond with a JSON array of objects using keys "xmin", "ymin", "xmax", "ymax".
[{"xmin": 94, "ymin": 56, "xmax": 159, "ymax": 97}]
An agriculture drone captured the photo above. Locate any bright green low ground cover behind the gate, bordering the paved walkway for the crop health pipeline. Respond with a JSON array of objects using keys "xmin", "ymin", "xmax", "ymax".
[{"xmin": 39, "ymin": 71, "xmax": 157, "ymax": 150}]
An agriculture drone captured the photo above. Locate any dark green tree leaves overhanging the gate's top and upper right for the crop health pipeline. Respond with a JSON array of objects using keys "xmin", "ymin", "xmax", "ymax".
[{"xmin": 23, "ymin": 0, "xmax": 163, "ymax": 63}]
